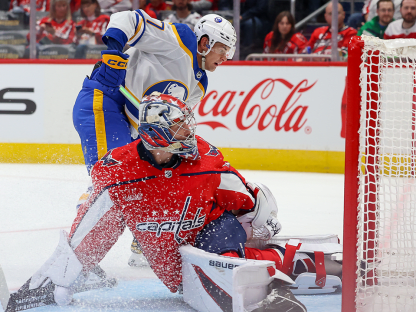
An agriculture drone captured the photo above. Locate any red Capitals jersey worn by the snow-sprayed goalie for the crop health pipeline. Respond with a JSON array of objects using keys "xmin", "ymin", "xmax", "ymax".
[{"xmin": 70, "ymin": 137, "xmax": 254, "ymax": 292}]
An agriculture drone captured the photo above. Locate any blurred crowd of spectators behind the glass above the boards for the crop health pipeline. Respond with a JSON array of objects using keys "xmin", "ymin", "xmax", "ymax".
[{"xmin": 0, "ymin": 0, "xmax": 416, "ymax": 61}]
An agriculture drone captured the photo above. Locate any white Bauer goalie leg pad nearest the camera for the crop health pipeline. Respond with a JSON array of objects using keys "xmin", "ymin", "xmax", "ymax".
[{"xmin": 180, "ymin": 245, "xmax": 294, "ymax": 312}]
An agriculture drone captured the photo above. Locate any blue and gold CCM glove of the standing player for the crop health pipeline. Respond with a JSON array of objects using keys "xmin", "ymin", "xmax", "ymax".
[{"xmin": 96, "ymin": 50, "xmax": 129, "ymax": 88}]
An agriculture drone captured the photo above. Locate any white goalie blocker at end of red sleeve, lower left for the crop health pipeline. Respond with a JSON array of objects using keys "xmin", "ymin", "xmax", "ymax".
[{"xmin": 29, "ymin": 231, "xmax": 82, "ymax": 289}]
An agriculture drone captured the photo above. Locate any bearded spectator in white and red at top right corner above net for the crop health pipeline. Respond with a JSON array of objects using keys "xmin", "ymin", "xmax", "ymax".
[{"xmin": 384, "ymin": 0, "xmax": 416, "ymax": 39}]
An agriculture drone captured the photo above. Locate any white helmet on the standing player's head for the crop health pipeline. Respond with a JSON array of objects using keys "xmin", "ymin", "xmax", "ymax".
[{"xmin": 194, "ymin": 14, "xmax": 237, "ymax": 60}]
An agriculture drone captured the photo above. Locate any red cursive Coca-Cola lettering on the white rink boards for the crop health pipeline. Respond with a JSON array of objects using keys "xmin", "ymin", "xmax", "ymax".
[{"xmin": 195, "ymin": 78, "xmax": 317, "ymax": 134}]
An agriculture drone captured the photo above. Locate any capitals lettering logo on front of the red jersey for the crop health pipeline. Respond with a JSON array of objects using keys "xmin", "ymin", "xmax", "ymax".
[{"xmin": 136, "ymin": 196, "xmax": 206, "ymax": 244}]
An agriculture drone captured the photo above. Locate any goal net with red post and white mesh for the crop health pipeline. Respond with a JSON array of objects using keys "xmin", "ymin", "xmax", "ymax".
[{"xmin": 342, "ymin": 36, "xmax": 416, "ymax": 312}]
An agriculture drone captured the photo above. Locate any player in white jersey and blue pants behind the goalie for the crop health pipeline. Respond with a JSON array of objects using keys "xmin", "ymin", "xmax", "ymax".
[{"xmin": 73, "ymin": 10, "xmax": 236, "ymax": 171}]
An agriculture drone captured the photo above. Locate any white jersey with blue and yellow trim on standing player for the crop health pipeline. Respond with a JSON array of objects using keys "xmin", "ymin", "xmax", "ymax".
[{"xmin": 103, "ymin": 10, "xmax": 208, "ymax": 133}]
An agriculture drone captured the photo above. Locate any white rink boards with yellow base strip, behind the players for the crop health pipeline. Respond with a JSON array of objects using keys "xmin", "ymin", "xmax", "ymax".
[{"xmin": 0, "ymin": 61, "xmax": 346, "ymax": 173}]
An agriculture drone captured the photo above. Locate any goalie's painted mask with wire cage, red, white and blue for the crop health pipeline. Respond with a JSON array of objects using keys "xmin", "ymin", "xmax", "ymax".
[{"xmin": 138, "ymin": 93, "xmax": 199, "ymax": 160}]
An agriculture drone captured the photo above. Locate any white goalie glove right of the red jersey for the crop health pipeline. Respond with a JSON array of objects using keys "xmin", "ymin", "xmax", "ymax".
[{"xmin": 237, "ymin": 182, "xmax": 282, "ymax": 240}]
